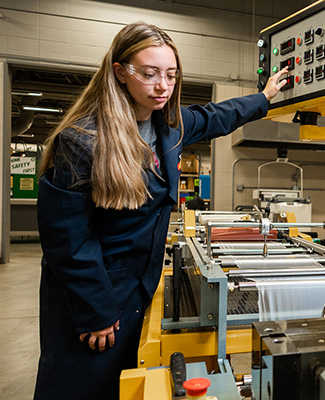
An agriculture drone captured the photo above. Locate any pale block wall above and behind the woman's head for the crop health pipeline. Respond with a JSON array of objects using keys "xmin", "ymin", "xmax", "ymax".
[{"xmin": 0, "ymin": 0, "xmax": 310, "ymax": 260}]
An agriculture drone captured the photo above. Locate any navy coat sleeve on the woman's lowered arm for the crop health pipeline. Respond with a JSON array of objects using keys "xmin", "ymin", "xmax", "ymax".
[{"xmin": 38, "ymin": 129, "xmax": 119, "ymax": 334}]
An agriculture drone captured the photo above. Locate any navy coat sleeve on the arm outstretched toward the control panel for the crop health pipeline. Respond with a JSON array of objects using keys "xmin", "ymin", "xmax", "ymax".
[{"xmin": 182, "ymin": 93, "xmax": 268, "ymax": 146}]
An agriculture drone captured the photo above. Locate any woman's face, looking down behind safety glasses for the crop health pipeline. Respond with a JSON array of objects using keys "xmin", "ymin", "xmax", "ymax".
[{"xmin": 116, "ymin": 45, "xmax": 177, "ymax": 121}]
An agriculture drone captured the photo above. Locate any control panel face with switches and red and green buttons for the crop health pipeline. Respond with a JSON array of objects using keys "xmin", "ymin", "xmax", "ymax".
[{"xmin": 257, "ymin": 1, "xmax": 325, "ymax": 109}]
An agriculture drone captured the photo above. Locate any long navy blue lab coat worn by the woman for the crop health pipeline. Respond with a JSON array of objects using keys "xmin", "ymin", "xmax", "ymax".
[{"xmin": 34, "ymin": 93, "xmax": 268, "ymax": 400}]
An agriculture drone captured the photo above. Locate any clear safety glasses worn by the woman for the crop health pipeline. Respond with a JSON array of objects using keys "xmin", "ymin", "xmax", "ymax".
[{"xmin": 123, "ymin": 63, "xmax": 179, "ymax": 86}]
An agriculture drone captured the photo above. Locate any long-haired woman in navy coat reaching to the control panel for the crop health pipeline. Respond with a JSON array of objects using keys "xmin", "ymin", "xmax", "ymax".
[{"xmin": 34, "ymin": 23, "xmax": 286, "ymax": 400}]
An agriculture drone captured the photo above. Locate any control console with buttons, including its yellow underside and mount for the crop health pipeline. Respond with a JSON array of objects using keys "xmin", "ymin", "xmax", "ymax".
[{"xmin": 257, "ymin": 0, "xmax": 325, "ymax": 141}]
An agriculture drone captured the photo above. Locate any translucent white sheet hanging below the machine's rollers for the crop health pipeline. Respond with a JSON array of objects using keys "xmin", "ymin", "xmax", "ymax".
[{"xmin": 256, "ymin": 278, "xmax": 325, "ymax": 321}]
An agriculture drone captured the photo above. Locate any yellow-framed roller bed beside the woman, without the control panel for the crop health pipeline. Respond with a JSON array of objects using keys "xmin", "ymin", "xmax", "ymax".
[{"xmin": 122, "ymin": 210, "xmax": 325, "ymax": 400}]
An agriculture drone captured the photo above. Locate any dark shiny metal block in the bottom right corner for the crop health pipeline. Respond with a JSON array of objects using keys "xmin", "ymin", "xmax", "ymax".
[{"xmin": 252, "ymin": 318, "xmax": 325, "ymax": 400}]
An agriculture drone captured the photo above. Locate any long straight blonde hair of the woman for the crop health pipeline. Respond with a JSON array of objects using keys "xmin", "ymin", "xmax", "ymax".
[{"xmin": 40, "ymin": 23, "xmax": 182, "ymax": 210}]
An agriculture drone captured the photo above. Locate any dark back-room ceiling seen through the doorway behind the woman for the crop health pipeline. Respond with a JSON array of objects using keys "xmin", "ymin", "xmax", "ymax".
[{"xmin": 11, "ymin": 66, "xmax": 212, "ymax": 144}]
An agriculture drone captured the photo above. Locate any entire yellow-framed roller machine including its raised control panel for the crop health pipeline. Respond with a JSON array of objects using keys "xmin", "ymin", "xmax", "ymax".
[{"xmin": 121, "ymin": 0, "xmax": 325, "ymax": 400}]
